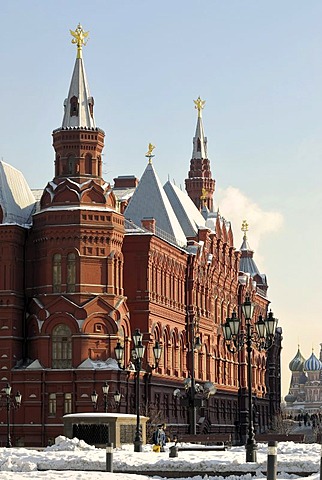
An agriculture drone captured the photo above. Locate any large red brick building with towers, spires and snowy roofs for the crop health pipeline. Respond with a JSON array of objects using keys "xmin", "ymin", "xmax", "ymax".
[{"xmin": 0, "ymin": 25, "xmax": 281, "ymax": 446}]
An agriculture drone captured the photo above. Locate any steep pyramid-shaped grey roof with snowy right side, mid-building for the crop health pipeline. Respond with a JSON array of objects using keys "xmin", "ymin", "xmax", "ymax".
[{"xmin": 124, "ymin": 163, "xmax": 187, "ymax": 249}]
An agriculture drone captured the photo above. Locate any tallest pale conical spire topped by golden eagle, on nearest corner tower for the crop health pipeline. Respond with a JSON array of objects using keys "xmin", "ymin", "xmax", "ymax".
[{"xmin": 62, "ymin": 24, "xmax": 95, "ymax": 129}]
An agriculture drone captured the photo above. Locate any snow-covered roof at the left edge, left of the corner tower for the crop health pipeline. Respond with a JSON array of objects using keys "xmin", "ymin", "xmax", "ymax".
[{"xmin": 0, "ymin": 161, "xmax": 36, "ymax": 225}]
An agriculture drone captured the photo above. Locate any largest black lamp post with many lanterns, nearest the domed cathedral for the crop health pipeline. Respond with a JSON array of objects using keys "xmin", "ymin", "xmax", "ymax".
[{"xmin": 222, "ymin": 295, "xmax": 277, "ymax": 462}]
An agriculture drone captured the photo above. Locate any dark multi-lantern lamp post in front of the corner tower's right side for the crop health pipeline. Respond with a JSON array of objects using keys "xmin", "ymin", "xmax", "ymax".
[{"xmin": 114, "ymin": 328, "xmax": 162, "ymax": 452}]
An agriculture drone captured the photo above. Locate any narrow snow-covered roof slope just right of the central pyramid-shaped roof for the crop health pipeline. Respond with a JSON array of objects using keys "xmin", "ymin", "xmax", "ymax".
[{"xmin": 163, "ymin": 181, "xmax": 205, "ymax": 237}]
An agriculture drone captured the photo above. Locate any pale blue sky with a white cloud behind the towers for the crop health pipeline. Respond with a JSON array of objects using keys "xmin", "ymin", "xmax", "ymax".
[{"xmin": 0, "ymin": 0, "xmax": 322, "ymax": 394}]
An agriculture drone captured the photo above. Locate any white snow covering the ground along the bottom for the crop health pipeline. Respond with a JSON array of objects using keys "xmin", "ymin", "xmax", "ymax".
[{"xmin": 0, "ymin": 436, "xmax": 321, "ymax": 480}]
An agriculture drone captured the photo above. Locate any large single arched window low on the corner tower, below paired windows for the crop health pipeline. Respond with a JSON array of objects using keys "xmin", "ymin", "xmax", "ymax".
[{"xmin": 52, "ymin": 324, "xmax": 72, "ymax": 369}]
